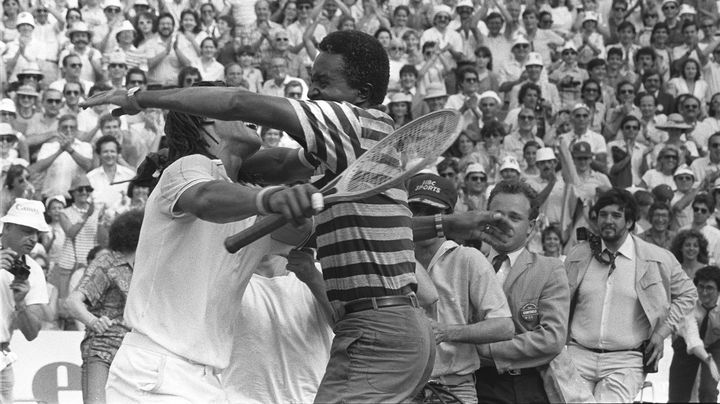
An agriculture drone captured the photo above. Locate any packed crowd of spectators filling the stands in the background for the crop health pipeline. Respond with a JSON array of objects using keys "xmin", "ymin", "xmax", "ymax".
[{"xmin": 5, "ymin": 0, "xmax": 720, "ymax": 398}]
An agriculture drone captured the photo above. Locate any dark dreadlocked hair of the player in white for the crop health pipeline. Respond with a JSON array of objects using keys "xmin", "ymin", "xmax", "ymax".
[{"xmin": 165, "ymin": 111, "xmax": 217, "ymax": 165}]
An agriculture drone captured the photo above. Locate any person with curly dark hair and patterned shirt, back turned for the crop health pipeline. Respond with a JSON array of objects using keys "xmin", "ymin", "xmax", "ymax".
[{"xmin": 66, "ymin": 210, "xmax": 143, "ymax": 403}]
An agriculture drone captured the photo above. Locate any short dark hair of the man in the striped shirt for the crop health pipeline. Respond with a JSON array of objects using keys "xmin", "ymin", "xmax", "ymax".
[{"xmin": 318, "ymin": 31, "xmax": 390, "ymax": 105}]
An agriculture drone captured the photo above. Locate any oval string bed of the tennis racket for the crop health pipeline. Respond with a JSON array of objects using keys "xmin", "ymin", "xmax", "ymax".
[{"xmin": 337, "ymin": 113, "xmax": 459, "ymax": 193}]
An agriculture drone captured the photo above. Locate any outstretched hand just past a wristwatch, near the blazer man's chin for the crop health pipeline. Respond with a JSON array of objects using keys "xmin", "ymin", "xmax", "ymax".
[{"xmin": 443, "ymin": 210, "xmax": 514, "ymax": 244}]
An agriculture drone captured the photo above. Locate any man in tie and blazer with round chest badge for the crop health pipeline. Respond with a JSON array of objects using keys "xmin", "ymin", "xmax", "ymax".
[{"xmin": 476, "ymin": 181, "xmax": 570, "ymax": 403}]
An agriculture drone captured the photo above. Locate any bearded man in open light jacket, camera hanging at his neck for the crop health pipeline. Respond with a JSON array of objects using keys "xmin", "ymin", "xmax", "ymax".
[{"xmin": 565, "ymin": 188, "xmax": 697, "ymax": 402}]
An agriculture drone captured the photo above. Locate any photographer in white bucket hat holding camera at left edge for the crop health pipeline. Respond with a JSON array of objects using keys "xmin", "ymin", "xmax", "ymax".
[{"xmin": 0, "ymin": 198, "xmax": 50, "ymax": 403}]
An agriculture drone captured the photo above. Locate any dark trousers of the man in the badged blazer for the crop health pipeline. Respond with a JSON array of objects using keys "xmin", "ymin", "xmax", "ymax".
[{"xmin": 475, "ymin": 368, "xmax": 549, "ymax": 404}]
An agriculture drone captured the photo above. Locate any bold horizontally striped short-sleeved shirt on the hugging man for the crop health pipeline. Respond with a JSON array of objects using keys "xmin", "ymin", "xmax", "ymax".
[{"xmin": 289, "ymin": 100, "xmax": 417, "ymax": 302}]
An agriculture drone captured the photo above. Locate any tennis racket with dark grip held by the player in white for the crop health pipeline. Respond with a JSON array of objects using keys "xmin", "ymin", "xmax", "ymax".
[{"xmin": 225, "ymin": 109, "xmax": 462, "ymax": 253}]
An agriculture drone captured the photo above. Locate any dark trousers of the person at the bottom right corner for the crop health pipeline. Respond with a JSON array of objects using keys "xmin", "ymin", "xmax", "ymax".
[{"xmin": 668, "ymin": 337, "xmax": 720, "ymax": 403}]
